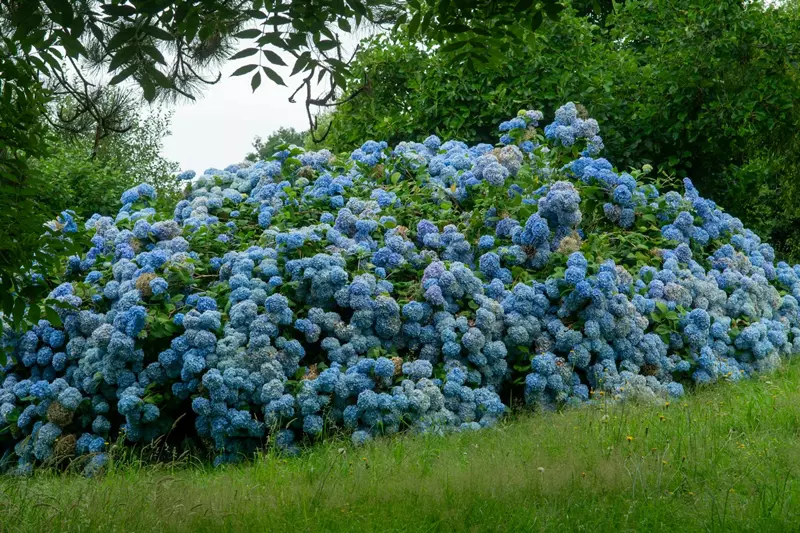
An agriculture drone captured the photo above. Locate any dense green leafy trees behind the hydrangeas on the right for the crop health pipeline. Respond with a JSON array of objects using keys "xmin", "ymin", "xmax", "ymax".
[{"xmin": 318, "ymin": 0, "xmax": 800, "ymax": 259}]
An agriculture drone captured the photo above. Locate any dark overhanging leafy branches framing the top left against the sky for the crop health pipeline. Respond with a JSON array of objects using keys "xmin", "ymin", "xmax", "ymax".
[{"xmin": 0, "ymin": 0, "xmax": 561, "ymax": 270}]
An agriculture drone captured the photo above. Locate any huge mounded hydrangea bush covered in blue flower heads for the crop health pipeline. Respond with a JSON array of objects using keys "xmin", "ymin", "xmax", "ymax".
[{"xmin": 0, "ymin": 103, "xmax": 800, "ymax": 473}]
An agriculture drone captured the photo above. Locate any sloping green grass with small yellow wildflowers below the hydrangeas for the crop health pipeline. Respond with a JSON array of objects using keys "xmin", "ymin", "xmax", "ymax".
[{"xmin": 0, "ymin": 361, "xmax": 800, "ymax": 533}]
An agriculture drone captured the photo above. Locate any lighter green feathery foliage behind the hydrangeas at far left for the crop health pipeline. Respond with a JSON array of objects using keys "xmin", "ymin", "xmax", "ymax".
[{"xmin": 0, "ymin": 89, "xmax": 180, "ymax": 326}]
